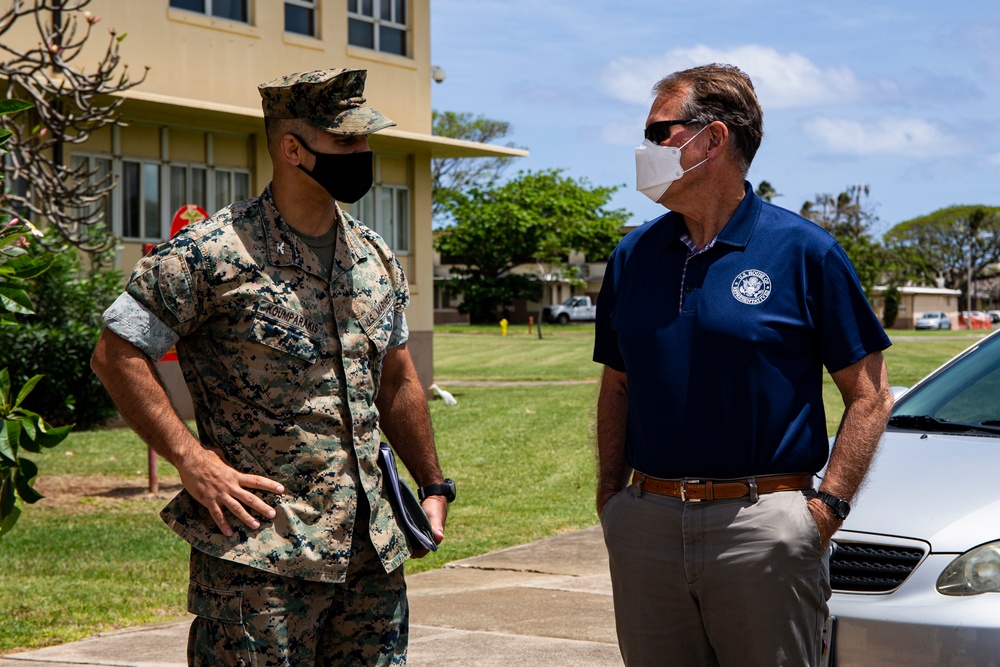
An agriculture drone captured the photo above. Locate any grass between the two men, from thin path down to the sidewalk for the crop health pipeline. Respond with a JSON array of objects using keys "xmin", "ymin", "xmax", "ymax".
[{"xmin": 407, "ymin": 384, "xmax": 597, "ymax": 571}]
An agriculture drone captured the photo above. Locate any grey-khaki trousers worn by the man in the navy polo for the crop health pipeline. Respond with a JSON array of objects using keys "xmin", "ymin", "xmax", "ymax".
[{"xmin": 601, "ymin": 487, "xmax": 831, "ymax": 667}]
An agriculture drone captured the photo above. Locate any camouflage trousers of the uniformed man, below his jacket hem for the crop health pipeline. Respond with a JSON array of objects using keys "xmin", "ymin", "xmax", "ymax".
[{"xmin": 188, "ymin": 539, "xmax": 409, "ymax": 667}]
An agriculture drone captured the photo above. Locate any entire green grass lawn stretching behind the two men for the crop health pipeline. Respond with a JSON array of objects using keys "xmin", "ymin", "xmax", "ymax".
[{"xmin": 0, "ymin": 325, "xmax": 974, "ymax": 654}]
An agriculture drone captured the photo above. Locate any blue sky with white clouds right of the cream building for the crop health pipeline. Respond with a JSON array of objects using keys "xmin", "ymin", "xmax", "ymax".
[{"xmin": 431, "ymin": 0, "xmax": 1000, "ymax": 231}]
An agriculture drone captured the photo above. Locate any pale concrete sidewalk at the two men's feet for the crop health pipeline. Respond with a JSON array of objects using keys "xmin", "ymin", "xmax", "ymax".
[{"xmin": 0, "ymin": 527, "xmax": 622, "ymax": 667}]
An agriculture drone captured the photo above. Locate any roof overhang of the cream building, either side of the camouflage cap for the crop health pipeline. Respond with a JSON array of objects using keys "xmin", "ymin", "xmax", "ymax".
[{"xmin": 114, "ymin": 89, "xmax": 530, "ymax": 158}]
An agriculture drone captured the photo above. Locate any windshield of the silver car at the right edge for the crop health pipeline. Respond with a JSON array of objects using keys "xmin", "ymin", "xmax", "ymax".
[{"xmin": 889, "ymin": 336, "xmax": 1000, "ymax": 436}]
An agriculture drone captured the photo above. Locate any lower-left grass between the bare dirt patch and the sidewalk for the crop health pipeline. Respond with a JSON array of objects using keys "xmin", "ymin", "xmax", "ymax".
[{"xmin": 0, "ymin": 497, "xmax": 188, "ymax": 654}]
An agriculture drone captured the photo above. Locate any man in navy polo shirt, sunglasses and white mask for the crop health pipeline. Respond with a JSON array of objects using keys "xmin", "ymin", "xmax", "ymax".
[{"xmin": 594, "ymin": 65, "xmax": 892, "ymax": 667}]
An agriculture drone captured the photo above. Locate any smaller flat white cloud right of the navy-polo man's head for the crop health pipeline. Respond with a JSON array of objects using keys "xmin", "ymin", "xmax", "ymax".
[{"xmin": 803, "ymin": 116, "xmax": 964, "ymax": 157}]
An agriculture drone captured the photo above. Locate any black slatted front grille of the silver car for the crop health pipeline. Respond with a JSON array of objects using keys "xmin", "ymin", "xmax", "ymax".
[{"xmin": 830, "ymin": 542, "xmax": 924, "ymax": 593}]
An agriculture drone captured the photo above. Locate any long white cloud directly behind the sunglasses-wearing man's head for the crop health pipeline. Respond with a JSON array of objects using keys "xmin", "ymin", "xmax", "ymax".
[{"xmin": 603, "ymin": 44, "xmax": 862, "ymax": 111}]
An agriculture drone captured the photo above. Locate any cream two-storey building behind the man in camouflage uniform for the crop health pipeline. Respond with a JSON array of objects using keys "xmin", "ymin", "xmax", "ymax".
[{"xmin": 7, "ymin": 0, "xmax": 526, "ymax": 412}]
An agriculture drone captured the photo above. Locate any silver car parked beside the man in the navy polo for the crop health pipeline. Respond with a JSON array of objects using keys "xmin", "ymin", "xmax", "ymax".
[{"xmin": 830, "ymin": 332, "xmax": 1000, "ymax": 667}]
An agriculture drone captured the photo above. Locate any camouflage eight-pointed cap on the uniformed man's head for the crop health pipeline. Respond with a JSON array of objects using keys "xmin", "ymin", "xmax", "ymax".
[{"xmin": 257, "ymin": 68, "xmax": 396, "ymax": 135}]
